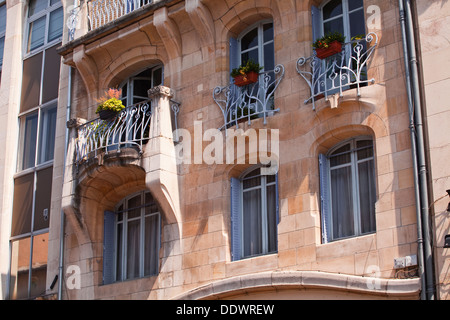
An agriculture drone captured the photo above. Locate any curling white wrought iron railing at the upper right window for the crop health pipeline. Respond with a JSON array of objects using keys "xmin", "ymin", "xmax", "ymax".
[{"xmin": 297, "ymin": 33, "xmax": 378, "ymax": 109}]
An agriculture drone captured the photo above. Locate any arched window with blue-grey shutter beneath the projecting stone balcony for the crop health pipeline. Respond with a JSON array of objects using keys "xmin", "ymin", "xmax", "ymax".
[{"xmin": 103, "ymin": 191, "xmax": 161, "ymax": 284}]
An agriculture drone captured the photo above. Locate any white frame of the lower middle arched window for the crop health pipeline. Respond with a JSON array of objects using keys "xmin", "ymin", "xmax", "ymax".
[{"xmin": 239, "ymin": 167, "xmax": 278, "ymax": 259}]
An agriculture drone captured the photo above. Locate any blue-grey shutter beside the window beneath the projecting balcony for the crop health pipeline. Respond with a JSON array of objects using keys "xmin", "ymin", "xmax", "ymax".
[{"xmin": 103, "ymin": 211, "xmax": 116, "ymax": 284}]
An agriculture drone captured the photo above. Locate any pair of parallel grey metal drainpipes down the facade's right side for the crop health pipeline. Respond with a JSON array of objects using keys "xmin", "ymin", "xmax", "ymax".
[{"xmin": 399, "ymin": 0, "xmax": 434, "ymax": 300}]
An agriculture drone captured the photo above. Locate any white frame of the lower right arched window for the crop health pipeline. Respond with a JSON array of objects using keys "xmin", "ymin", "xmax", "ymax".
[{"xmin": 322, "ymin": 136, "xmax": 377, "ymax": 241}]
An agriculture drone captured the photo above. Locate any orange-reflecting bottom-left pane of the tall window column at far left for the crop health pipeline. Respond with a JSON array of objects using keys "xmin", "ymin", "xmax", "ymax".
[{"xmin": 9, "ymin": 237, "xmax": 31, "ymax": 300}]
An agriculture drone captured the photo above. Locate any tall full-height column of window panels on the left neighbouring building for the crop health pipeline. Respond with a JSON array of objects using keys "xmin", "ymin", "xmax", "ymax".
[{"xmin": 9, "ymin": 0, "xmax": 63, "ymax": 299}]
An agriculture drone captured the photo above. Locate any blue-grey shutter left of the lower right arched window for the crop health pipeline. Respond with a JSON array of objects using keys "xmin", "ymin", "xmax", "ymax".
[{"xmin": 319, "ymin": 154, "xmax": 331, "ymax": 243}]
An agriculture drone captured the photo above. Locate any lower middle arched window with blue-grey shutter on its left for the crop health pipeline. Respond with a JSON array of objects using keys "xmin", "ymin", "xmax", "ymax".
[{"xmin": 231, "ymin": 168, "xmax": 278, "ymax": 260}]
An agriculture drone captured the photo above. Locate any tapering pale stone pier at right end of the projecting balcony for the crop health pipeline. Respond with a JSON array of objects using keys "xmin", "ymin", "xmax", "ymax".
[{"xmin": 143, "ymin": 86, "xmax": 181, "ymax": 230}]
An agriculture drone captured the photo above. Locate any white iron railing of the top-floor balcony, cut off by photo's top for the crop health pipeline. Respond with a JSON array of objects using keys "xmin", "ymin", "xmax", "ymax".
[{"xmin": 87, "ymin": 0, "xmax": 153, "ymax": 30}]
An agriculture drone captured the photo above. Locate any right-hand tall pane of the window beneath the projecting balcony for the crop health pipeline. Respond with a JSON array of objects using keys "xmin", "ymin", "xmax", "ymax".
[{"xmin": 144, "ymin": 214, "xmax": 159, "ymax": 276}]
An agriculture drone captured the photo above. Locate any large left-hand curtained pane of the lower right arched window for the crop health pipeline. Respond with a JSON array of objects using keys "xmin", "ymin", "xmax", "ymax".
[{"xmin": 331, "ymin": 166, "xmax": 354, "ymax": 239}]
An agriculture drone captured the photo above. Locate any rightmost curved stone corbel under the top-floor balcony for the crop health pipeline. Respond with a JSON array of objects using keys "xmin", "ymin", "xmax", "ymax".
[{"xmin": 185, "ymin": 0, "xmax": 215, "ymax": 58}]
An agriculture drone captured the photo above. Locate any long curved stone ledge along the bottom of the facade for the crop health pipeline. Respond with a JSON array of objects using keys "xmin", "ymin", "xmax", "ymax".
[{"xmin": 173, "ymin": 271, "xmax": 420, "ymax": 300}]
